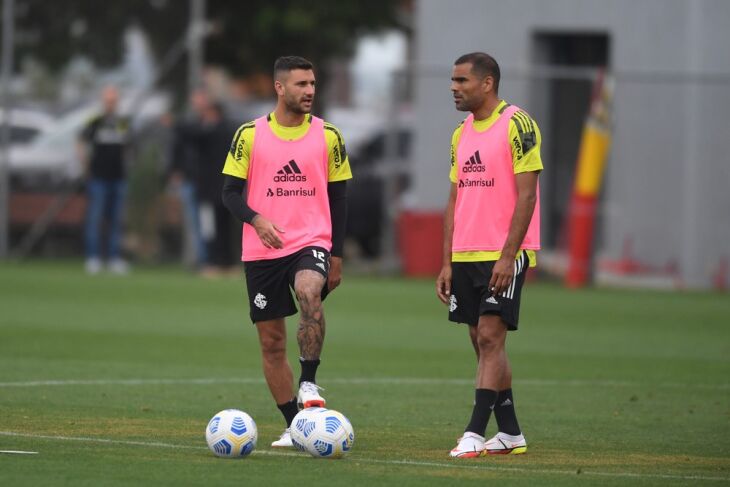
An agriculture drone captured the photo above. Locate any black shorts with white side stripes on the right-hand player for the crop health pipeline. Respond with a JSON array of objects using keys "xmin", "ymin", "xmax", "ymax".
[{"xmin": 449, "ymin": 250, "xmax": 530, "ymax": 330}]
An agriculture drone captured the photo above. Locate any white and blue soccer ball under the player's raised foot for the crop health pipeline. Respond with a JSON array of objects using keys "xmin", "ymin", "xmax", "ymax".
[{"xmin": 291, "ymin": 408, "xmax": 355, "ymax": 458}]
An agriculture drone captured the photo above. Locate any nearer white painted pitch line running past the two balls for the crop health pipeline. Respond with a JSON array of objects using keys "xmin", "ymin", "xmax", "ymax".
[{"xmin": 0, "ymin": 431, "xmax": 730, "ymax": 482}]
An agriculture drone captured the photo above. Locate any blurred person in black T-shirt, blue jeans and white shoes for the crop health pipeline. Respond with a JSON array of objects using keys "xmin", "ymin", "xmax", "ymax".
[{"xmin": 78, "ymin": 86, "xmax": 131, "ymax": 274}]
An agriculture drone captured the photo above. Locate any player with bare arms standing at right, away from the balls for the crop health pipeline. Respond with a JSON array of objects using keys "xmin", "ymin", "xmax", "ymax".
[{"xmin": 436, "ymin": 52, "xmax": 543, "ymax": 458}]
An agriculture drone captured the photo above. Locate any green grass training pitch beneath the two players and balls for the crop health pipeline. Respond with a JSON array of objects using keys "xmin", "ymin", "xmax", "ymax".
[{"xmin": 0, "ymin": 262, "xmax": 730, "ymax": 486}]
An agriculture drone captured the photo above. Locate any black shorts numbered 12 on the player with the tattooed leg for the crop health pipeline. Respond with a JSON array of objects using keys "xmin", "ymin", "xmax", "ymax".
[{"xmin": 243, "ymin": 247, "xmax": 330, "ymax": 323}]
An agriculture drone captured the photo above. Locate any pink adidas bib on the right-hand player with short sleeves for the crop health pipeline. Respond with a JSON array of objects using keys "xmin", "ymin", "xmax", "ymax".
[{"xmin": 452, "ymin": 105, "xmax": 540, "ymax": 252}]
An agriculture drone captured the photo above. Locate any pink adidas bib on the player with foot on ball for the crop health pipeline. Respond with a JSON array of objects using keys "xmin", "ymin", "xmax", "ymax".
[{"xmin": 241, "ymin": 117, "xmax": 332, "ymax": 261}]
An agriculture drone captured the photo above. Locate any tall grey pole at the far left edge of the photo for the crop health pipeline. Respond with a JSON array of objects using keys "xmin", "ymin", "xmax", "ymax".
[{"xmin": 0, "ymin": 0, "xmax": 15, "ymax": 259}]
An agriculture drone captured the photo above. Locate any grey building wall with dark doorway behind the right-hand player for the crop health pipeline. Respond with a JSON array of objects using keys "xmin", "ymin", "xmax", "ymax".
[{"xmin": 412, "ymin": 0, "xmax": 730, "ymax": 287}]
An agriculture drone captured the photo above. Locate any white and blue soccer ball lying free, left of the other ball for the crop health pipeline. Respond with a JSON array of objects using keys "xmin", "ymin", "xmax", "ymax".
[{"xmin": 205, "ymin": 409, "xmax": 259, "ymax": 458}]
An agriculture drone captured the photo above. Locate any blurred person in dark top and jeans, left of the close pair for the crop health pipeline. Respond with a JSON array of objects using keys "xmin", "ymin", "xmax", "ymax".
[{"xmin": 168, "ymin": 89, "xmax": 211, "ymax": 270}]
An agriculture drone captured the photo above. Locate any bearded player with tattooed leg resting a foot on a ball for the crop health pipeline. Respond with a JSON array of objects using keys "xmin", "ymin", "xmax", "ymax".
[{"xmin": 223, "ymin": 56, "xmax": 352, "ymax": 447}]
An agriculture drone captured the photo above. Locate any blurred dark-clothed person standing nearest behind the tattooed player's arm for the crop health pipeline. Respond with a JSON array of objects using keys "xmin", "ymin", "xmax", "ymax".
[{"xmin": 196, "ymin": 102, "xmax": 241, "ymax": 277}]
